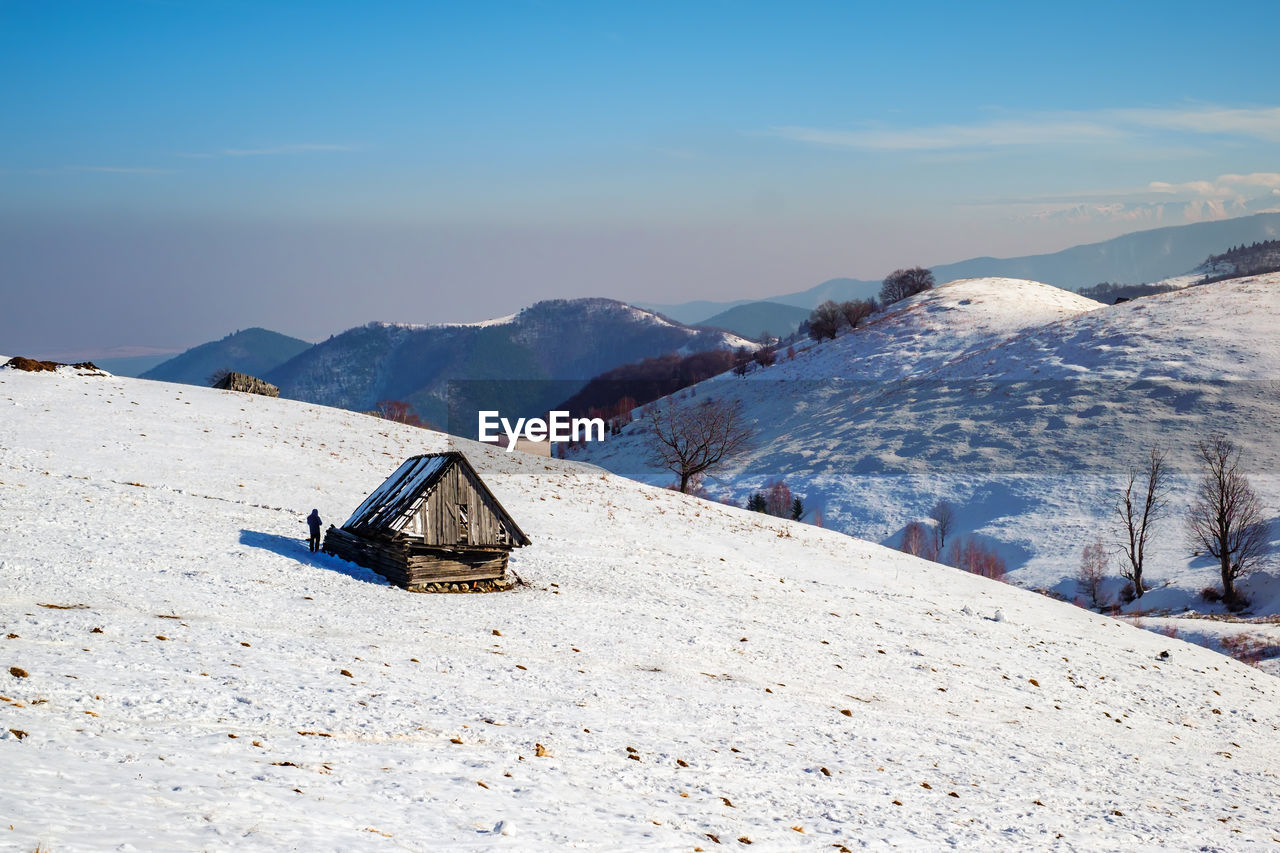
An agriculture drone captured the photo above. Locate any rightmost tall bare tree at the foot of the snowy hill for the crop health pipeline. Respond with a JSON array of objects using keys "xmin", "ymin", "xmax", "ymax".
[{"xmin": 1187, "ymin": 434, "xmax": 1271, "ymax": 605}]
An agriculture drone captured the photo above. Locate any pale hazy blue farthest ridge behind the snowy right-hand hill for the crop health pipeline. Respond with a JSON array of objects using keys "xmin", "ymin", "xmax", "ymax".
[{"xmin": 644, "ymin": 213, "xmax": 1280, "ymax": 324}]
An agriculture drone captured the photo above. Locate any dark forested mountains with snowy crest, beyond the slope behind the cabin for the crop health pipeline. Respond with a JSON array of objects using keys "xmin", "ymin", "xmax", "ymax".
[{"xmin": 145, "ymin": 298, "xmax": 750, "ymax": 437}]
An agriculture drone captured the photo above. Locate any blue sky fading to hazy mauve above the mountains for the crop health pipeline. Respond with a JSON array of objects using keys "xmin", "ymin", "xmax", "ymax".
[{"xmin": 0, "ymin": 0, "xmax": 1280, "ymax": 353}]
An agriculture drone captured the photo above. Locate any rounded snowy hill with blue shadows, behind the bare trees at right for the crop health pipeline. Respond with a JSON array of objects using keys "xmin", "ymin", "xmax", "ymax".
[{"xmin": 581, "ymin": 274, "xmax": 1280, "ymax": 612}]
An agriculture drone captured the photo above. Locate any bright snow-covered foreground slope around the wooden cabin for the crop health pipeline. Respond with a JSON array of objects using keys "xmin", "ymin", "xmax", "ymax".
[{"xmin": 0, "ymin": 370, "xmax": 1280, "ymax": 852}]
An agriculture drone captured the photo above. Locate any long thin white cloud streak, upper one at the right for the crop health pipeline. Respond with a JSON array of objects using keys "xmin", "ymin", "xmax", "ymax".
[{"xmin": 768, "ymin": 106, "xmax": 1280, "ymax": 151}]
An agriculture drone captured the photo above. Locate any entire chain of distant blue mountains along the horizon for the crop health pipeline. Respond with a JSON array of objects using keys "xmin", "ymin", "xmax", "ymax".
[{"xmin": 142, "ymin": 214, "xmax": 1280, "ymax": 435}]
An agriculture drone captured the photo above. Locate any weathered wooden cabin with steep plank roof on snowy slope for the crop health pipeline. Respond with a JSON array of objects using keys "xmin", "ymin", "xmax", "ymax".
[{"xmin": 324, "ymin": 451, "xmax": 530, "ymax": 592}]
